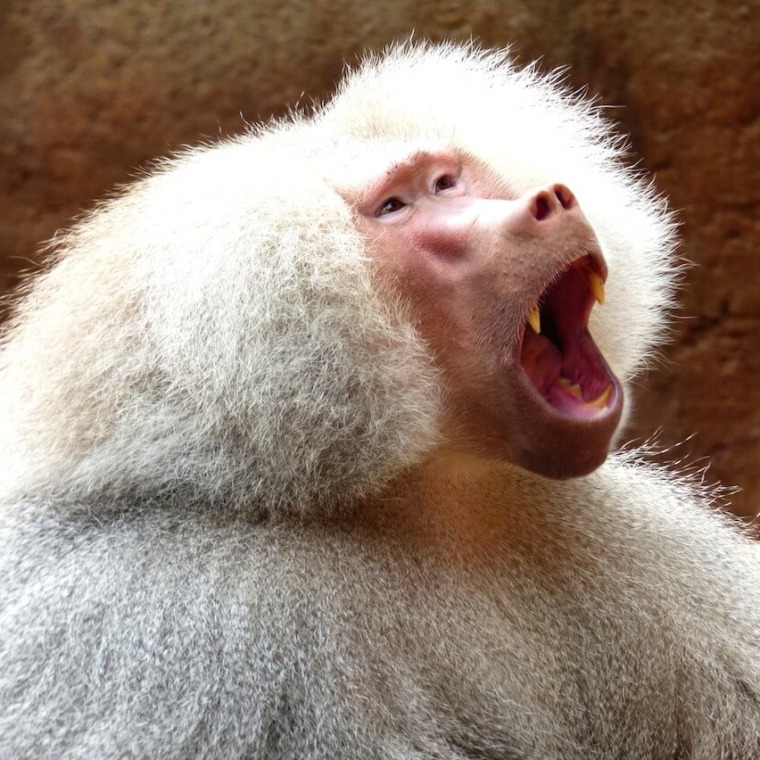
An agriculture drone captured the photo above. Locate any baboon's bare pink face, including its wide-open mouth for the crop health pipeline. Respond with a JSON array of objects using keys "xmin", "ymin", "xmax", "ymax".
[{"xmin": 356, "ymin": 151, "xmax": 623, "ymax": 478}]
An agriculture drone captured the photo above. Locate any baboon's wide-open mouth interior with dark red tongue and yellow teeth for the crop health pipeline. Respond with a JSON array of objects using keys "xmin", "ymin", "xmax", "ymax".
[{"xmin": 520, "ymin": 254, "xmax": 618, "ymax": 419}]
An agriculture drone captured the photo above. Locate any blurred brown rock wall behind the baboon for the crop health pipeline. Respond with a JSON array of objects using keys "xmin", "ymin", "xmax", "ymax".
[{"xmin": 0, "ymin": 0, "xmax": 760, "ymax": 516}]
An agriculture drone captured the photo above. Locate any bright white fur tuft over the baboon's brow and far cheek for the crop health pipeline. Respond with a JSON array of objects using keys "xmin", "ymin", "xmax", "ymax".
[{"xmin": 322, "ymin": 38, "xmax": 678, "ymax": 382}]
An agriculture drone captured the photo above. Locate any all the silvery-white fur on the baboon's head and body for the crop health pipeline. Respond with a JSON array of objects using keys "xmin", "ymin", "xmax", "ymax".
[{"xmin": 0, "ymin": 46, "xmax": 760, "ymax": 760}]
